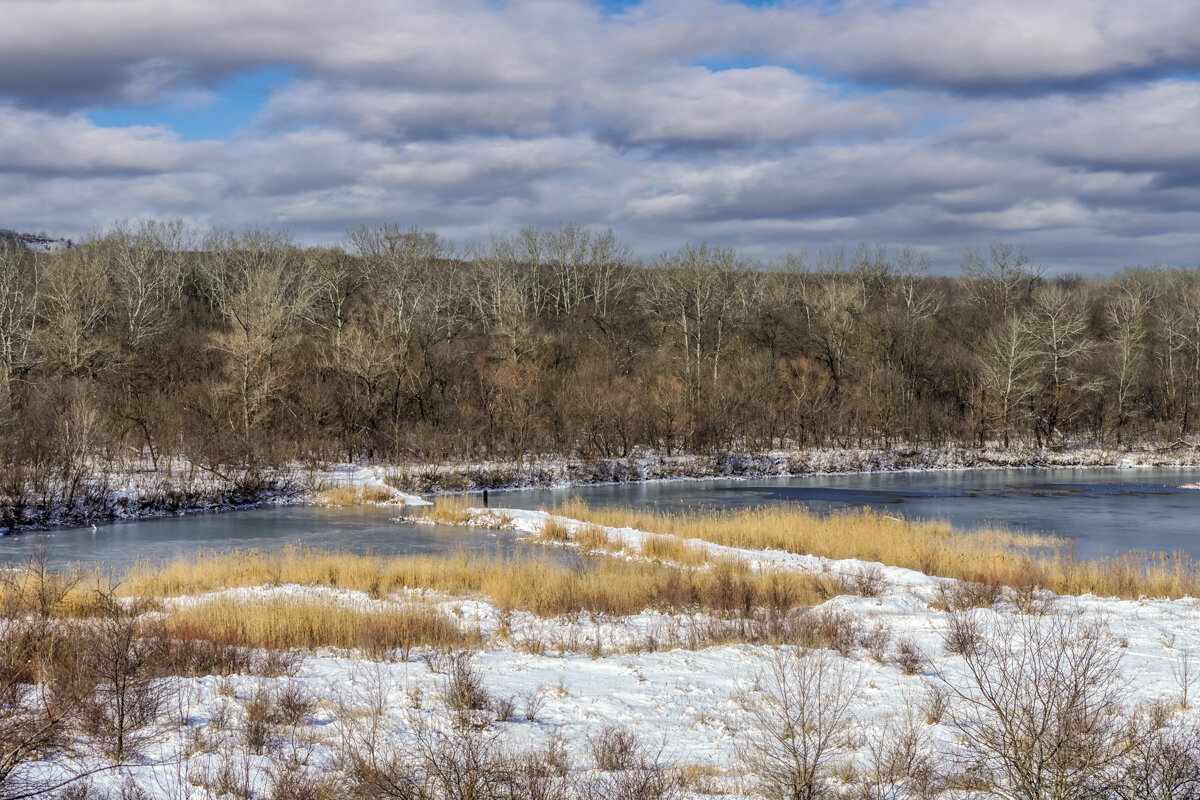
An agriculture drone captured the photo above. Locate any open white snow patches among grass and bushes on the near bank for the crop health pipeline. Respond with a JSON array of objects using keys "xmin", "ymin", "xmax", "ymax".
[{"xmin": 23, "ymin": 506, "xmax": 1200, "ymax": 798}]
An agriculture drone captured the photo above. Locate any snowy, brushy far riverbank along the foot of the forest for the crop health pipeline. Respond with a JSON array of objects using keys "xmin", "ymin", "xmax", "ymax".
[{"xmin": 0, "ymin": 443, "xmax": 1200, "ymax": 535}]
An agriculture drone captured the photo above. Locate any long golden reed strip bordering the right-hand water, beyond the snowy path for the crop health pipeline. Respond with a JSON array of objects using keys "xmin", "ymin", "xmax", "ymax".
[{"xmin": 553, "ymin": 500, "xmax": 1200, "ymax": 599}]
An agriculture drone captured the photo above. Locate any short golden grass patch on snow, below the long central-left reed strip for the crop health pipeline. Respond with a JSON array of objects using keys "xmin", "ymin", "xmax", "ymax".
[{"xmin": 163, "ymin": 597, "xmax": 480, "ymax": 654}]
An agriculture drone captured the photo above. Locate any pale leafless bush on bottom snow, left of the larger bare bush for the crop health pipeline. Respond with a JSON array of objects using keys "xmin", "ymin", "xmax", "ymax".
[{"xmin": 739, "ymin": 649, "xmax": 860, "ymax": 800}]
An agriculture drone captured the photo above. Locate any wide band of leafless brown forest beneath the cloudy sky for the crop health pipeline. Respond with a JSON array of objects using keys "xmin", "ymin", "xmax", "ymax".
[{"xmin": 0, "ymin": 221, "xmax": 1200, "ymax": 495}]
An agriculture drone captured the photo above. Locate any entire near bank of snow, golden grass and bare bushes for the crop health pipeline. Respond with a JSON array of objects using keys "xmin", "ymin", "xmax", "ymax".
[{"xmin": 0, "ymin": 489, "xmax": 1200, "ymax": 800}]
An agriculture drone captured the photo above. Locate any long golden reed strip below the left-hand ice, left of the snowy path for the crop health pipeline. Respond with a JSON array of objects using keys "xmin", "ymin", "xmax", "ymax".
[{"xmin": 122, "ymin": 547, "xmax": 842, "ymax": 615}]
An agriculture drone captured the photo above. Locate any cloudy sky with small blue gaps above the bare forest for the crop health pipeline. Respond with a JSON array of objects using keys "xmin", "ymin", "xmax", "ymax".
[{"xmin": 0, "ymin": 0, "xmax": 1200, "ymax": 275}]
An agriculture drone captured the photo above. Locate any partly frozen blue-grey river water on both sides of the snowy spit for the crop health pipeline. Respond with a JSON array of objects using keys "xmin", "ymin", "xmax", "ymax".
[{"xmin": 0, "ymin": 468, "xmax": 1200, "ymax": 572}]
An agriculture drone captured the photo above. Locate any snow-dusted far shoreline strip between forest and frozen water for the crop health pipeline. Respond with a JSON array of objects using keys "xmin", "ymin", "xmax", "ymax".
[{"xmin": 0, "ymin": 445, "xmax": 1200, "ymax": 536}]
